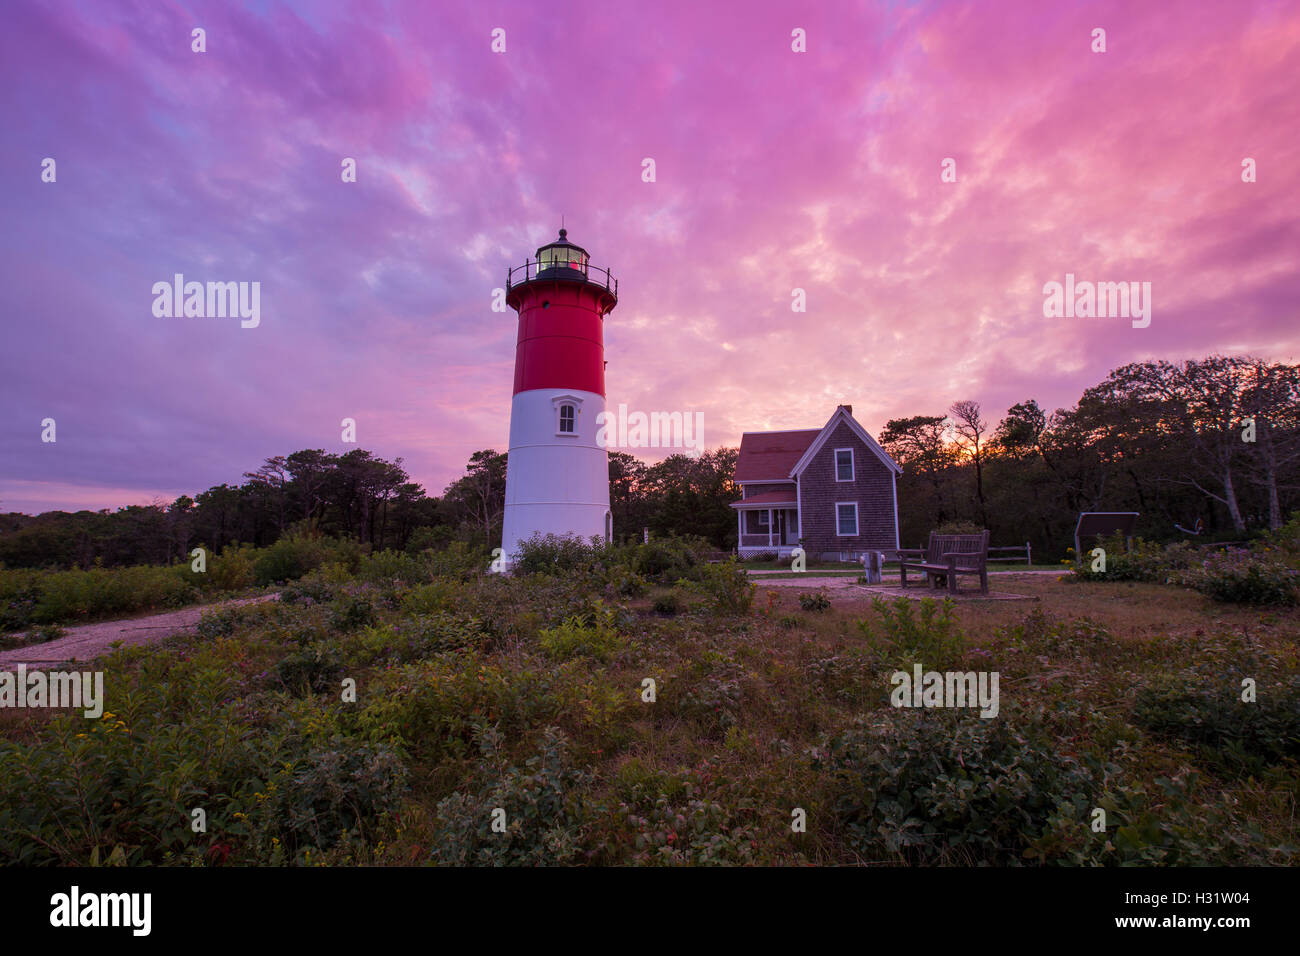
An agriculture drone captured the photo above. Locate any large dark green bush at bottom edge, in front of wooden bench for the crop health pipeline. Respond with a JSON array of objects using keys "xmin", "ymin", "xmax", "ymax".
[{"xmin": 814, "ymin": 710, "xmax": 1097, "ymax": 865}]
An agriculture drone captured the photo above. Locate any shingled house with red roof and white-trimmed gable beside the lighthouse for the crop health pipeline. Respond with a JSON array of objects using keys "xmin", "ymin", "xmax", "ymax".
[{"xmin": 732, "ymin": 405, "xmax": 902, "ymax": 561}]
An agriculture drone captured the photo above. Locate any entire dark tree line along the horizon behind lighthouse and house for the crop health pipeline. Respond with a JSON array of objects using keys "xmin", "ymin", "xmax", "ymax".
[{"xmin": 0, "ymin": 356, "xmax": 1300, "ymax": 567}]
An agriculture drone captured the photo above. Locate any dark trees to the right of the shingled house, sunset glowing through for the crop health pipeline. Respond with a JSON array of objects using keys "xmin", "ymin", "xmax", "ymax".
[{"xmin": 880, "ymin": 355, "xmax": 1300, "ymax": 555}]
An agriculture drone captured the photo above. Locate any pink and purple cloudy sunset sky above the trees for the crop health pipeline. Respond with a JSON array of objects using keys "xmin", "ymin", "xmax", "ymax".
[{"xmin": 0, "ymin": 0, "xmax": 1300, "ymax": 514}]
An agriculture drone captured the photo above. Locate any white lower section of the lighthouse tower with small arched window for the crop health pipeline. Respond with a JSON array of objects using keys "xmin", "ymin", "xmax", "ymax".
[{"xmin": 502, "ymin": 389, "xmax": 614, "ymax": 566}]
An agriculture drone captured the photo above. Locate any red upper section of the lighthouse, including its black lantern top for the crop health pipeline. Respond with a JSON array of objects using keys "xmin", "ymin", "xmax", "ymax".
[{"xmin": 506, "ymin": 229, "xmax": 619, "ymax": 397}]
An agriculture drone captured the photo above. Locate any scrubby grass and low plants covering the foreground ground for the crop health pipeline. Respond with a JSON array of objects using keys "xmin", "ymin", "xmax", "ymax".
[{"xmin": 0, "ymin": 548, "xmax": 1300, "ymax": 865}]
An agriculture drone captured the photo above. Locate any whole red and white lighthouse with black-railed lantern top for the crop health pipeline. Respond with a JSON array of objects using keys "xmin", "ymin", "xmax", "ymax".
[{"xmin": 502, "ymin": 229, "xmax": 619, "ymax": 564}]
